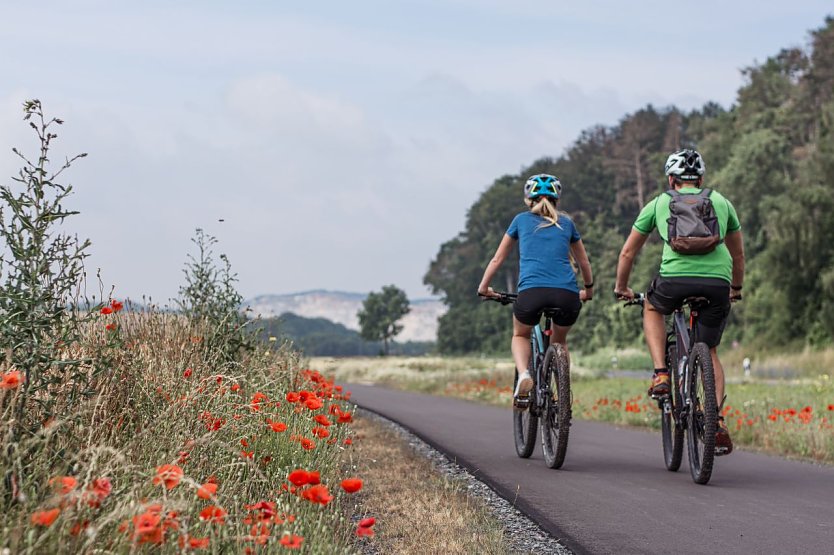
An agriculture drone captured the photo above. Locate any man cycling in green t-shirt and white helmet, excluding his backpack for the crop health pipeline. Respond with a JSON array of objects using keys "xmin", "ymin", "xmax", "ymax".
[{"xmin": 614, "ymin": 149, "xmax": 744, "ymax": 455}]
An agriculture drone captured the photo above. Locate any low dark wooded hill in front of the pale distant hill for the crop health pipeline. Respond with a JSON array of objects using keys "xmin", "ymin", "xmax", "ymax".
[{"xmin": 255, "ymin": 312, "xmax": 434, "ymax": 356}]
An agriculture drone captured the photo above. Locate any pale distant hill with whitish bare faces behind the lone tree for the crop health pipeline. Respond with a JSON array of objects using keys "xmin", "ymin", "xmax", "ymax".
[{"xmin": 245, "ymin": 289, "xmax": 446, "ymax": 342}]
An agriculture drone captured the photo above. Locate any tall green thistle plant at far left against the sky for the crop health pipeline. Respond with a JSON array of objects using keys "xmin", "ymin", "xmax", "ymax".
[{"xmin": 0, "ymin": 100, "xmax": 100, "ymax": 474}]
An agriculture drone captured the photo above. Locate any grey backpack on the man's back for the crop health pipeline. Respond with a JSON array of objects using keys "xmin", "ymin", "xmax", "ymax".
[{"xmin": 666, "ymin": 189, "xmax": 721, "ymax": 254}]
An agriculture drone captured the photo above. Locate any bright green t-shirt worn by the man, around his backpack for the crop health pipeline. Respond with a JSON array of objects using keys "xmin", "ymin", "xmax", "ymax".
[{"xmin": 634, "ymin": 187, "xmax": 741, "ymax": 282}]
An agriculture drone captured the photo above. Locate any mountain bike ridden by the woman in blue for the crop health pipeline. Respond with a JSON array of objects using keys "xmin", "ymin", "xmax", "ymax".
[{"xmin": 484, "ymin": 291, "xmax": 572, "ymax": 468}]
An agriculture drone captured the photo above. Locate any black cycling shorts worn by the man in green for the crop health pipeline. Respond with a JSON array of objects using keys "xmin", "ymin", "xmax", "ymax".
[{"xmin": 646, "ymin": 276, "xmax": 730, "ymax": 347}]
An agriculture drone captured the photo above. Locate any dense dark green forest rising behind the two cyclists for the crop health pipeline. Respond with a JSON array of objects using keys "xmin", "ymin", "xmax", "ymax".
[{"xmin": 424, "ymin": 17, "xmax": 834, "ymax": 353}]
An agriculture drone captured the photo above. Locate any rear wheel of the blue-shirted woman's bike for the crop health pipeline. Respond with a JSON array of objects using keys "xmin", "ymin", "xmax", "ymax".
[{"xmin": 541, "ymin": 343, "xmax": 571, "ymax": 468}]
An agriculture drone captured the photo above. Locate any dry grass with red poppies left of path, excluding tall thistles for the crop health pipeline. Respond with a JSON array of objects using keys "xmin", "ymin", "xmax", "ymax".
[{"xmin": 0, "ymin": 312, "xmax": 355, "ymax": 554}]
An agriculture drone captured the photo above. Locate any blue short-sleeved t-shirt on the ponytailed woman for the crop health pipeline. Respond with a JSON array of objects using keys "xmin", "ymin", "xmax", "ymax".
[{"xmin": 507, "ymin": 212, "xmax": 580, "ymax": 293}]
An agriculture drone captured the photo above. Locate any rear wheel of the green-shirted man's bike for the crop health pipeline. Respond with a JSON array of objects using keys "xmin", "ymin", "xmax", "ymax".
[{"xmin": 686, "ymin": 343, "xmax": 718, "ymax": 484}]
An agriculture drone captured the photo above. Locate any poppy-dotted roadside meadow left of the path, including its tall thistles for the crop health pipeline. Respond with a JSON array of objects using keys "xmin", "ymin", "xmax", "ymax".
[{"xmin": 0, "ymin": 101, "xmax": 375, "ymax": 553}]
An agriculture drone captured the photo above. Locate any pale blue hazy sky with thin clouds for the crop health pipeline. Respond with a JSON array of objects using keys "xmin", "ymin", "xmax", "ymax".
[{"xmin": 0, "ymin": 0, "xmax": 834, "ymax": 302}]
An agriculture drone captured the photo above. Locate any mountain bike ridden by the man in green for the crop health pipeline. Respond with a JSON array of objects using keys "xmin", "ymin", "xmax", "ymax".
[{"xmin": 626, "ymin": 293, "xmax": 721, "ymax": 484}]
